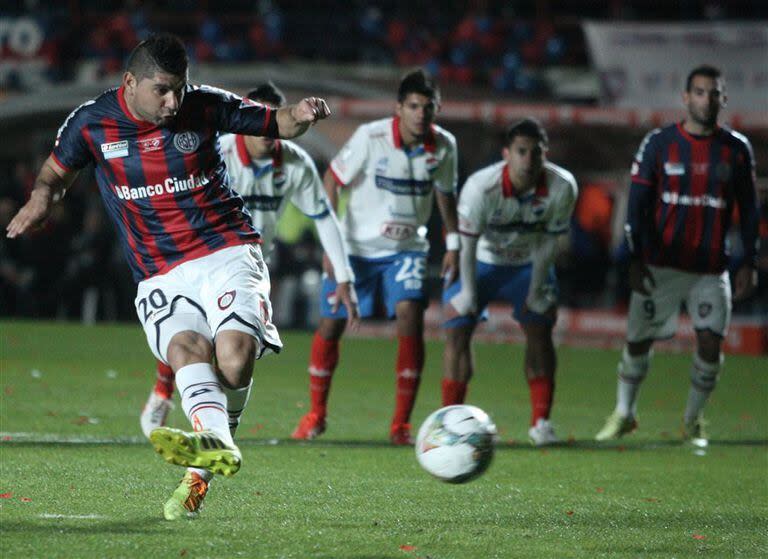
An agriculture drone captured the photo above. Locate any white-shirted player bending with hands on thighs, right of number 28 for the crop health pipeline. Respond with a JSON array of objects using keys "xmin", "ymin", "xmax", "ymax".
[{"xmin": 442, "ymin": 119, "xmax": 578, "ymax": 446}]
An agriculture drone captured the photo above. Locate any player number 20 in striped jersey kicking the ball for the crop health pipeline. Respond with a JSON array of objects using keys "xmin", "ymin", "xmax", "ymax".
[{"xmin": 7, "ymin": 34, "xmax": 329, "ymax": 520}]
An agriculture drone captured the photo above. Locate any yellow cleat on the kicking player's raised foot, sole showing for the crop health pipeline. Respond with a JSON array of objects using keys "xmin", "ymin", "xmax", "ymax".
[{"xmin": 149, "ymin": 427, "xmax": 242, "ymax": 477}]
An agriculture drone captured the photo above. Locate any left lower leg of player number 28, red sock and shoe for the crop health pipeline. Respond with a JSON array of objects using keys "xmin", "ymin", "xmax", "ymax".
[{"xmin": 291, "ymin": 317, "xmax": 347, "ymax": 440}]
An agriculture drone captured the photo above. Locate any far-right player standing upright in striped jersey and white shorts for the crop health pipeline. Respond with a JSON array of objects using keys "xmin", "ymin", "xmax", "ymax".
[{"xmin": 595, "ymin": 66, "xmax": 759, "ymax": 447}]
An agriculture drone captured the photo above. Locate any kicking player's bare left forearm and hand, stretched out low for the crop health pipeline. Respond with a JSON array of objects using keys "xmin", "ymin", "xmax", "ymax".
[{"xmin": 6, "ymin": 156, "xmax": 77, "ymax": 239}]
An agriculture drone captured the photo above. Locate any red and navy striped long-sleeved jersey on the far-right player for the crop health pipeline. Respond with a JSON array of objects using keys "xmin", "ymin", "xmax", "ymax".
[{"xmin": 626, "ymin": 123, "xmax": 758, "ymax": 273}]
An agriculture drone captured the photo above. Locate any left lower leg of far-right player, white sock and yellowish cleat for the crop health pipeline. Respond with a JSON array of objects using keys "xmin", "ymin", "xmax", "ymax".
[{"xmin": 595, "ymin": 340, "xmax": 653, "ymax": 441}]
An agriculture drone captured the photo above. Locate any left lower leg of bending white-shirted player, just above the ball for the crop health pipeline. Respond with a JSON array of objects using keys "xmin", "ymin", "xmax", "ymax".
[{"xmin": 442, "ymin": 324, "xmax": 475, "ymax": 406}]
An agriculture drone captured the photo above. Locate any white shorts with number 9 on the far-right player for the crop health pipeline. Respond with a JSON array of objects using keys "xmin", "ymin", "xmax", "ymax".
[{"xmin": 627, "ymin": 266, "xmax": 731, "ymax": 342}]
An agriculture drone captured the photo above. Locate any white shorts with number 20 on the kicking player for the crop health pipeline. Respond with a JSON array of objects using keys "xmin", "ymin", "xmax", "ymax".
[{"xmin": 135, "ymin": 244, "xmax": 283, "ymax": 363}]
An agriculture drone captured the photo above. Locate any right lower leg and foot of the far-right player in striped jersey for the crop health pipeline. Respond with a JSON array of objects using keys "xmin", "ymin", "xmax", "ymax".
[{"xmin": 683, "ymin": 330, "xmax": 723, "ymax": 448}]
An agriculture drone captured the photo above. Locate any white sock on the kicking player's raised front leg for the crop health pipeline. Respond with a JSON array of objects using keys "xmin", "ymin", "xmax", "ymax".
[{"xmin": 176, "ymin": 363, "xmax": 234, "ymax": 446}]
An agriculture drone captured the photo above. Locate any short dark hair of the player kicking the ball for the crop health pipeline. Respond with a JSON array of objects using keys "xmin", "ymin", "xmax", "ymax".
[{"xmin": 125, "ymin": 33, "xmax": 189, "ymax": 80}]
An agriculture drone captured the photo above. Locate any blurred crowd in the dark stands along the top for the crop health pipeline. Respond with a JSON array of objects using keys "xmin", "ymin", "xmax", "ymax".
[{"xmin": 0, "ymin": 0, "xmax": 768, "ymax": 95}]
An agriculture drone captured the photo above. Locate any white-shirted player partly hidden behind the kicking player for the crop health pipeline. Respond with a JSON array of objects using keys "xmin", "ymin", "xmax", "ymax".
[{"xmin": 141, "ymin": 82, "xmax": 358, "ymax": 437}]
